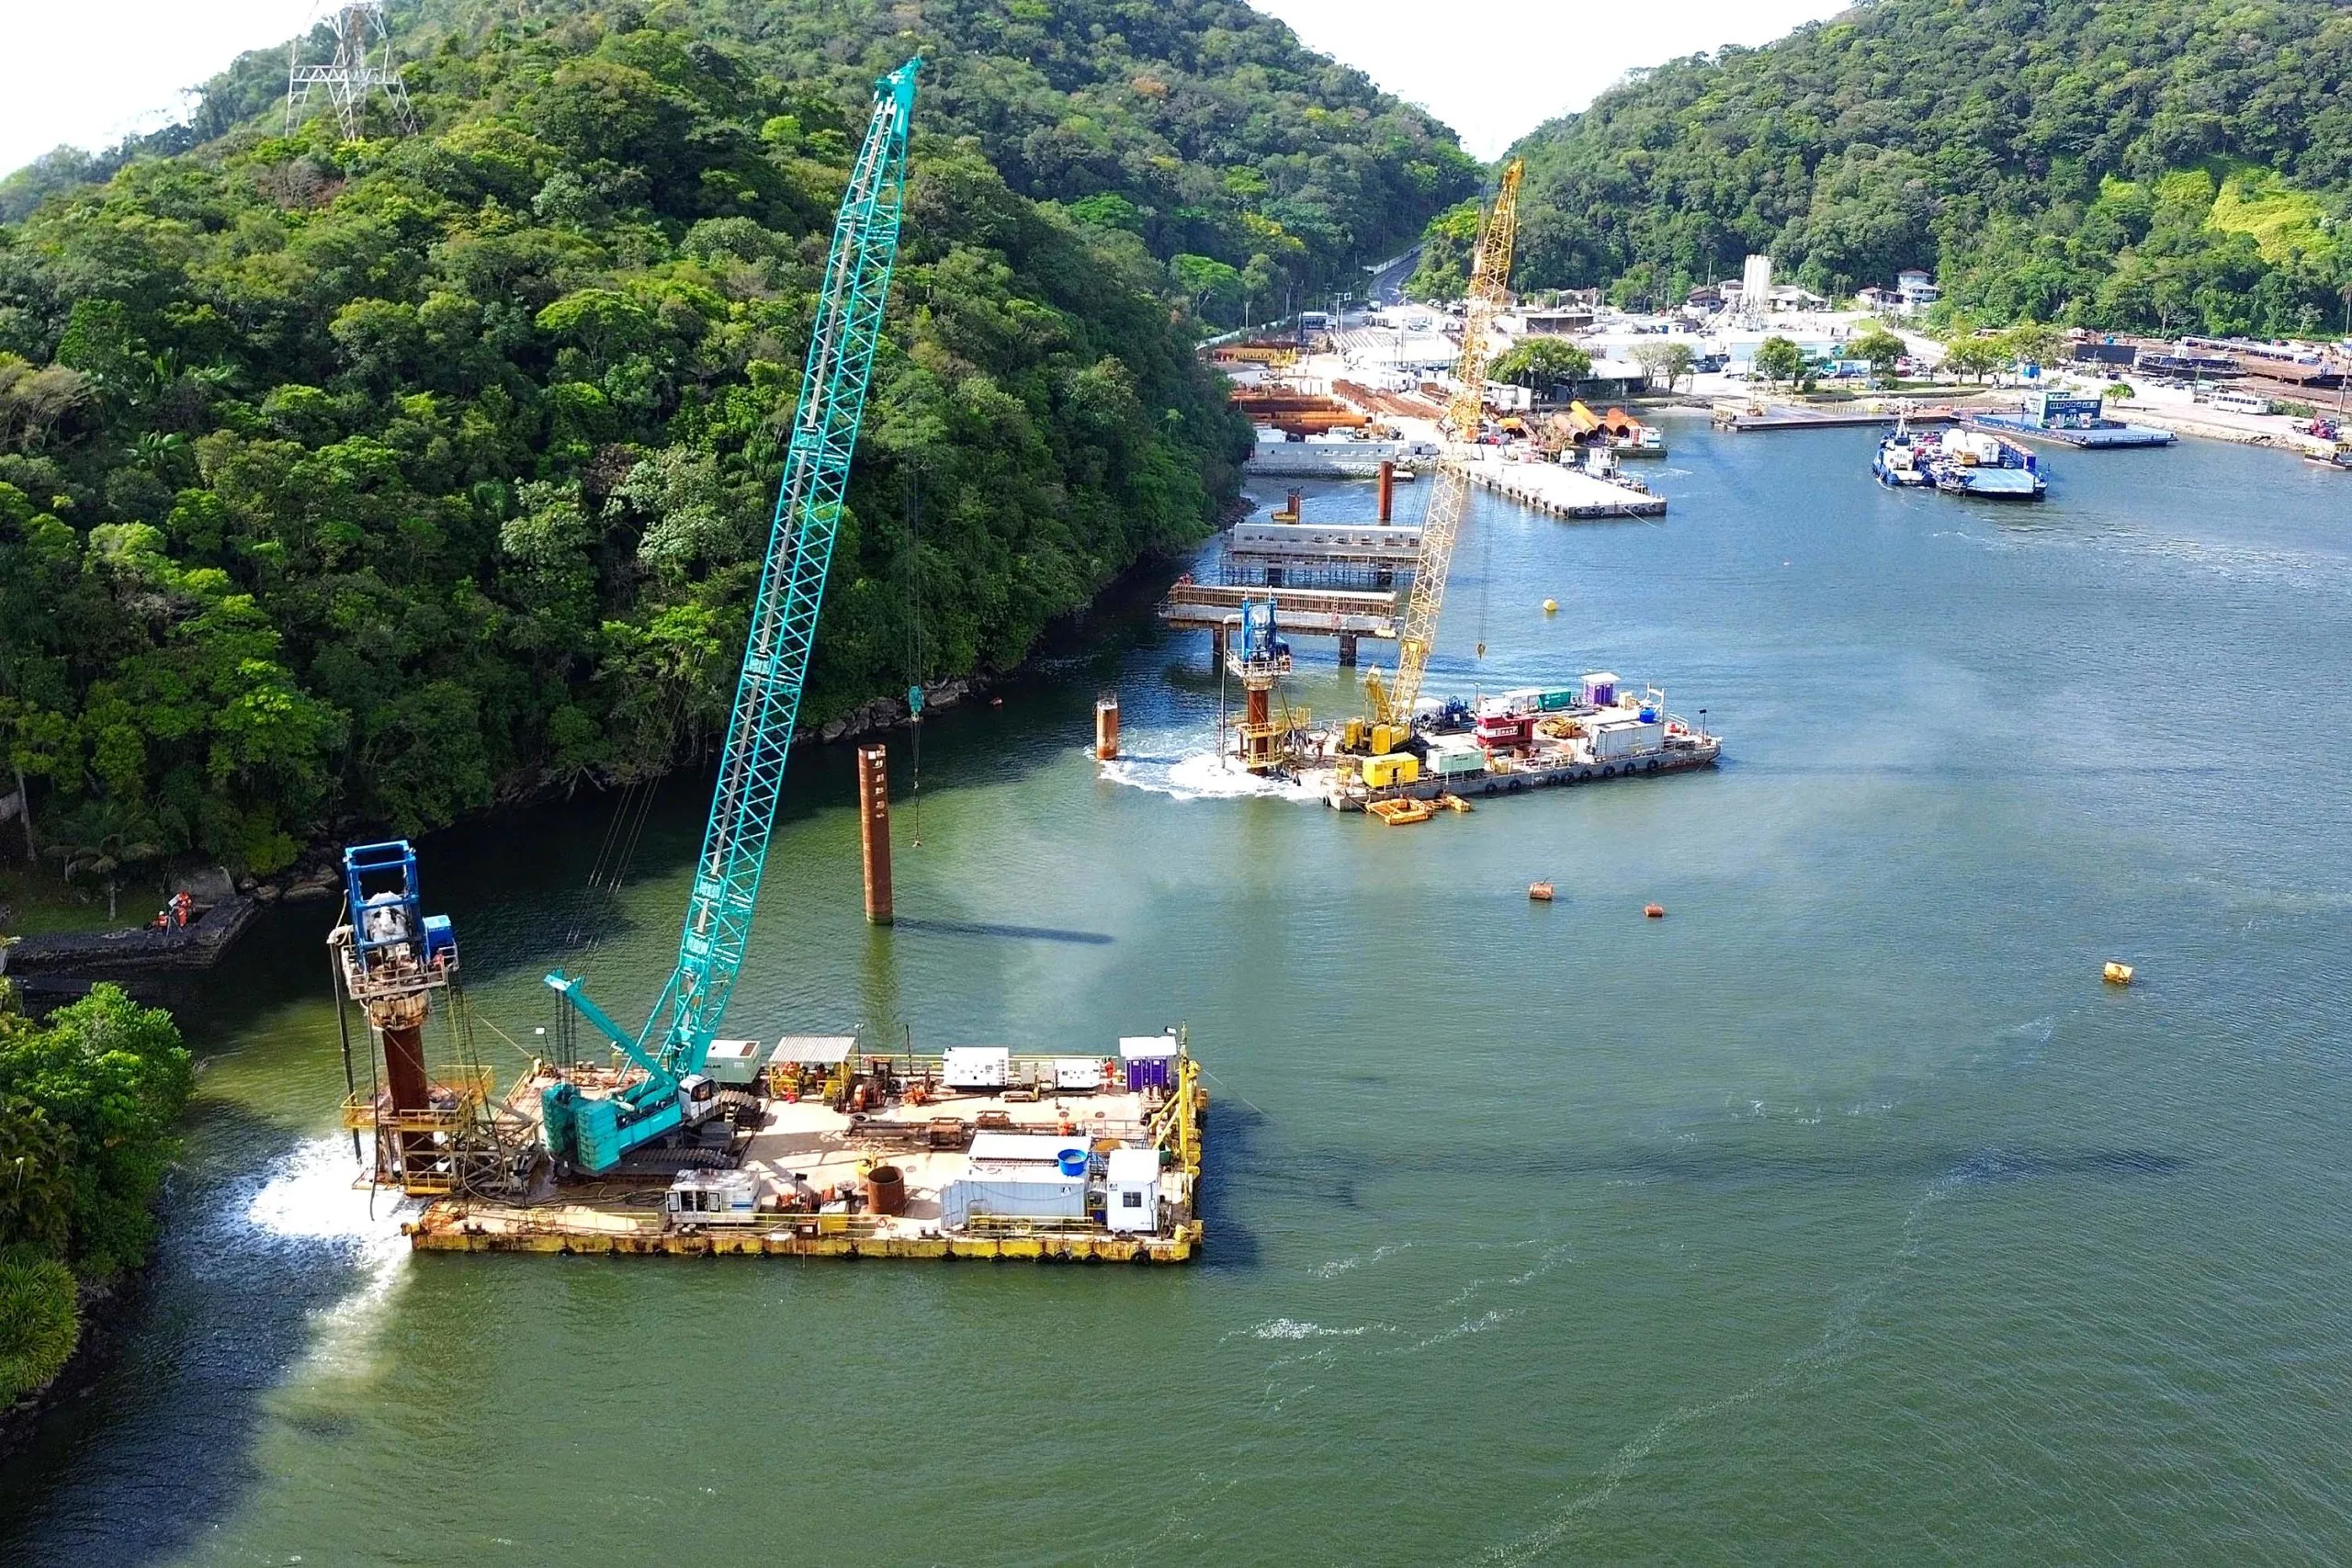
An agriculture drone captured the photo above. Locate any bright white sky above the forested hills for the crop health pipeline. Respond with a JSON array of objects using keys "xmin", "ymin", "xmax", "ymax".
[{"xmin": 0, "ymin": 0, "xmax": 1844, "ymax": 172}]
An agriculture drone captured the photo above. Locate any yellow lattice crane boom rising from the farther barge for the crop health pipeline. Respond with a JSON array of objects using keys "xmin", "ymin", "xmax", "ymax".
[{"xmin": 1364, "ymin": 160, "xmax": 1521, "ymax": 724}]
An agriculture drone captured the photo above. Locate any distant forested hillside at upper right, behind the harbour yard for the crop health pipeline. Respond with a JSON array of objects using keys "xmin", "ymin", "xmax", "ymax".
[{"xmin": 1486, "ymin": 0, "xmax": 2352, "ymax": 333}]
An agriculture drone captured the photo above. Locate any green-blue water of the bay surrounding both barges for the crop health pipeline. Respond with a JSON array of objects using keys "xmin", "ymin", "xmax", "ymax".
[{"xmin": 0, "ymin": 423, "xmax": 2352, "ymax": 1568}]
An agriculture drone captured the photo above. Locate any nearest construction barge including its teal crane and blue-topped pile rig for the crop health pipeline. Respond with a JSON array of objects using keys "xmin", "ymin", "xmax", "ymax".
[{"xmin": 327, "ymin": 59, "xmax": 1209, "ymax": 1262}]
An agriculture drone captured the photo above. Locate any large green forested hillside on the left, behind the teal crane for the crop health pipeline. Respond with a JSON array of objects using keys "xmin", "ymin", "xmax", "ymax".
[{"xmin": 0, "ymin": 0, "xmax": 1475, "ymax": 870}]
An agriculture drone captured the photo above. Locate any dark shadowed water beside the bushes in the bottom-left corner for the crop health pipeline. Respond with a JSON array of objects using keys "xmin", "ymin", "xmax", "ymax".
[{"xmin": 0, "ymin": 1105, "xmax": 385, "ymax": 1568}]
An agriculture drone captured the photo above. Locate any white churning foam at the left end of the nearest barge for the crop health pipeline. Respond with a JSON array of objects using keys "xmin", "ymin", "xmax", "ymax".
[{"xmin": 244, "ymin": 1138, "xmax": 416, "ymax": 1378}]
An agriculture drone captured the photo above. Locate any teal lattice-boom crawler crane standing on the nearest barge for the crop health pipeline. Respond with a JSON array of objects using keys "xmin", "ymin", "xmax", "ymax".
[{"xmin": 541, "ymin": 59, "xmax": 922, "ymax": 1173}]
